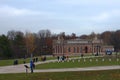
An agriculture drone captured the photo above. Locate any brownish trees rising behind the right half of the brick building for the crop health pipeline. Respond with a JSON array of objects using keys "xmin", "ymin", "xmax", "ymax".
[{"xmin": 80, "ymin": 30, "xmax": 120, "ymax": 52}]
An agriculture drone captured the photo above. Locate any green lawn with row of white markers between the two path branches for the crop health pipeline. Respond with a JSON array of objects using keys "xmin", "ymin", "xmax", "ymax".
[{"xmin": 36, "ymin": 57, "xmax": 120, "ymax": 69}]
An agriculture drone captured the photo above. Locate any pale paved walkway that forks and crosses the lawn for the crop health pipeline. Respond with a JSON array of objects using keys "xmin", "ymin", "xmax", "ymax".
[{"xmin": 0, "ymin": 60, "xmax": 120, "ymax": 74}]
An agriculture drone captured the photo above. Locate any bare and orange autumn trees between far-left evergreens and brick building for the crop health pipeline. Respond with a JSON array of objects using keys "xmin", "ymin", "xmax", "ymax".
[{"xmin": 7, "ymin": 30, "xmax": 52, "ymax": 58}]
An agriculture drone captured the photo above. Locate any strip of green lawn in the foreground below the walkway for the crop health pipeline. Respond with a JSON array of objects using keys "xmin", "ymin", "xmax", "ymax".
[{"xmin": 0, "ymin": 70, "xmax": 120, "ymax": 80}]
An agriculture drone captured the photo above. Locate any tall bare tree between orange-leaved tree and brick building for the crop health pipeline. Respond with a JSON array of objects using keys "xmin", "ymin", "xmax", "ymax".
[{"xmin": 37, "ymin": 29, "xmax": 52, "ymax": 55}]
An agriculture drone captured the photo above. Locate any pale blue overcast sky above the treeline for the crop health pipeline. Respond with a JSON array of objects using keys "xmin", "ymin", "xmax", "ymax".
[{"xmin": 0, "ymin": 0, "xmax": 120, "ymax": 35}]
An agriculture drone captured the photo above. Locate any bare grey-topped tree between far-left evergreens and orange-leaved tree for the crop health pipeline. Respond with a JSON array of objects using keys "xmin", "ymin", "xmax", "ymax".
[{"xmin": 7, "ymin": 30, "xmax": 25, "ymax": 58}]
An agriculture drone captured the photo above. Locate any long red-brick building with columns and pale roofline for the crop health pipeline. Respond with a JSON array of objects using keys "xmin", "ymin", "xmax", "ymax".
[{"xmin": 53, "ymin": 37, "xmax": 114, "ymax": 56}]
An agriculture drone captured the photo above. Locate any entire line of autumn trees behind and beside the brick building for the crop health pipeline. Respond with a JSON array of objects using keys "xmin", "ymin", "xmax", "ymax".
[{"xmin": 0, "ymin": 30, "xmax": 120, "ymax": 59}]
